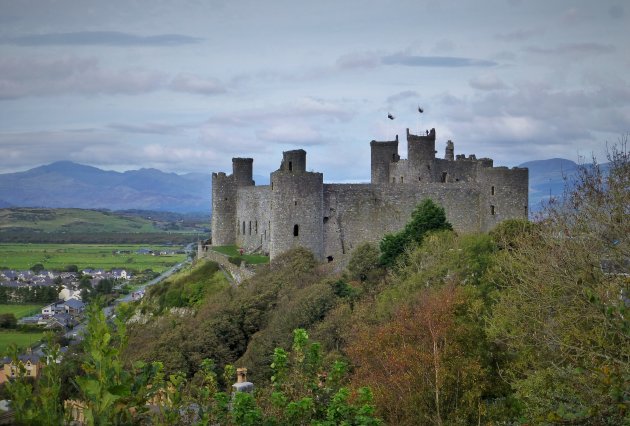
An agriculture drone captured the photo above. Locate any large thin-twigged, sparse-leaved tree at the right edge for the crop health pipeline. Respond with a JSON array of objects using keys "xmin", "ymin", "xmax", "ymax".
[{"xmin": 488, "ymin": 139, "xmax": 630, "ymax": 424}]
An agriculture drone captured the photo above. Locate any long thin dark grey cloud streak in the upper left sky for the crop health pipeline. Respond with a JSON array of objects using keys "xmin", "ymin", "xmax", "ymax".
[{"xmin": 2, "ymin": 31, "xmax": 203, "ymax": 46}]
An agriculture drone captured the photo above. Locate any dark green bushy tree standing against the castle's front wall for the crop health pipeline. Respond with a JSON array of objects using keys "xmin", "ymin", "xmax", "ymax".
[{"xmin": 380, "ymin": 198, "xmax": 453, "ymax": 267}]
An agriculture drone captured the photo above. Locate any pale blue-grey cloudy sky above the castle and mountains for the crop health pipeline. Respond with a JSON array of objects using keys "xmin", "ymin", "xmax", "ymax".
[{"xmin": 0, "ymin": 0, "xmax": 630, "ymax": 182}]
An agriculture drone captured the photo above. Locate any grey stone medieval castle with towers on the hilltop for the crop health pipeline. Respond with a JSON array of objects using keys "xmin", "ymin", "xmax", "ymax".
[{"xmin": 212, "ymin": 129, "xmax": 528, "ymax": 260}]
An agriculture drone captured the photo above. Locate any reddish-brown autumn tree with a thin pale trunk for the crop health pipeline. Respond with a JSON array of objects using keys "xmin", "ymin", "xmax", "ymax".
[{"xmin": 347, "ymin": 284, "xmax": 489, "ymax": 425}]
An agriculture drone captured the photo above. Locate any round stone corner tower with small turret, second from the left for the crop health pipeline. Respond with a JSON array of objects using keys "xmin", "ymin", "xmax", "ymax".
[{"xmin": 269, "ymin": 149, "xmax": 324, "ymax": 261}]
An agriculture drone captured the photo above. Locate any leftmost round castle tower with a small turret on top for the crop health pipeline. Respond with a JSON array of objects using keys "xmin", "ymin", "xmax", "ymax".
[{"xmin": 211, "ymin": 158, "xmax": 254, "ymax": 246}]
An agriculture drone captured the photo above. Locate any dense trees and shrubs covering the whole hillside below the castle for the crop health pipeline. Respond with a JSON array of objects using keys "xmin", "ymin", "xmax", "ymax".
[{"xmin": 6, "ymin": 144, "xmax": 630, "ymax": 425}]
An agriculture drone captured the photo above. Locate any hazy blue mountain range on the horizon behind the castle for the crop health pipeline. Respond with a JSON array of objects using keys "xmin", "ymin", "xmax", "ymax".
[{"xmin": 0, "ymin": 158, "xmax": 600, "ymax": 213}]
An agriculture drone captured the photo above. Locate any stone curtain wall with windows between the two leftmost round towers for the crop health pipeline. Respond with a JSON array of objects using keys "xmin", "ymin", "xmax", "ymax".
[{"xmin": 235, "ymin": 186, "xmax": 271, "ymax": 253}]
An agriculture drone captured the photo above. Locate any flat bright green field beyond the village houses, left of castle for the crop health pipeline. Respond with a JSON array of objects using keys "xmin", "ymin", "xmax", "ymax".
[{"xmin": 0, "ymin": 244, "xmax": 186, "ymax": 272}]
